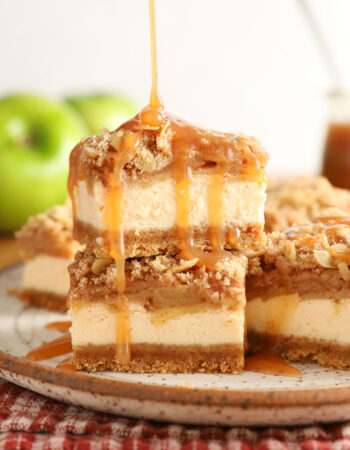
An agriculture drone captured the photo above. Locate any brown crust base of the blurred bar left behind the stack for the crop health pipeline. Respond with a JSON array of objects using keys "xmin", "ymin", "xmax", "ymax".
[{"xmin": 11, "ymin": 289, "xmax": 67, "ymax": 312}]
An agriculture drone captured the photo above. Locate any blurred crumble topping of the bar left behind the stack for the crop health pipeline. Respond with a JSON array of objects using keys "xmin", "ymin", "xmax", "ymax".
[{"xmin": 16, "ymin": 202, "xmax": 80, "ymax": 259}]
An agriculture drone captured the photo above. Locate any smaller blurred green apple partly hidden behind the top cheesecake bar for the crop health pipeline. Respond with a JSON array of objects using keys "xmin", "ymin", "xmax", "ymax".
[{"xmin": 66, "ymin": 95, "xmax": 138, "ymax": 134}]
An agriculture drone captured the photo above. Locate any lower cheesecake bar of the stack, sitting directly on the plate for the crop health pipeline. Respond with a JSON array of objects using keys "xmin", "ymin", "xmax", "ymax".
[{"xmin": 69, "ymin": 252, "xmax": 246, "ymax": 373}]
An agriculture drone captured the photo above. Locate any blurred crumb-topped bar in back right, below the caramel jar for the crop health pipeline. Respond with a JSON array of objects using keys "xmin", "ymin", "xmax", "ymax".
[{"xmin": 265, "ymin": 176, "xmax": 350, "ymax": 232}]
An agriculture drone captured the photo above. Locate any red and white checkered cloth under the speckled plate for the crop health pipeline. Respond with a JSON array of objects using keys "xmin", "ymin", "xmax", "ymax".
[{"xmin": 0, "ymin": 380, "xmax": 350, "ymax": 450}]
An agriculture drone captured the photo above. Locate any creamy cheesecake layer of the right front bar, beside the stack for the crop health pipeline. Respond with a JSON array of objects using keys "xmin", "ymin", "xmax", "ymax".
[{"xmin": 247, "ymin": 295, "xmax": 350, "ymax": 345}]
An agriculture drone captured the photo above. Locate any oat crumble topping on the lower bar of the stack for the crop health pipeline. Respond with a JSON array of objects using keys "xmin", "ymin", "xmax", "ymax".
[{"xmin": 69, "ymin": 252, "xmax": 247, "ymax": 303}]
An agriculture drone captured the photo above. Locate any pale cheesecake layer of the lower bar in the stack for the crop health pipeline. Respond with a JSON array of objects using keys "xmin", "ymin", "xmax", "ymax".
[{"xmin": 70, "ymin": 302, "xmax": 244, "ymax": 347}]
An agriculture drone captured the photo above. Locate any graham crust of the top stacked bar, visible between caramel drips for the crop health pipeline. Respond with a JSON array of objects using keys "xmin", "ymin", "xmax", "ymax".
[{"xmin": 74, "ymin": 220, "xmax": 266, "ymax": 258}]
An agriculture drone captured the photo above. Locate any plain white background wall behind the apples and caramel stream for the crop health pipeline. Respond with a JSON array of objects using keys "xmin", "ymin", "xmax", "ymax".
[{"xmin": 0, "ymin": 0, "xmax": 350, "ymax": 173}]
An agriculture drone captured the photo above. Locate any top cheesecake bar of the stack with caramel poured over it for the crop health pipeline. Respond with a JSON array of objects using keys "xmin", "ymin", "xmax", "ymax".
[{"xmin": 69, "ymin": 120, "xmax": 268, "ymax": 258}]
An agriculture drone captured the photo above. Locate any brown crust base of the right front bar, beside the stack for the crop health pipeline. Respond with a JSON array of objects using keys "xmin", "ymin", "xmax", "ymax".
[{"xmin": 248, "ymin": 331, "xmax": 350, "ymax": 370}]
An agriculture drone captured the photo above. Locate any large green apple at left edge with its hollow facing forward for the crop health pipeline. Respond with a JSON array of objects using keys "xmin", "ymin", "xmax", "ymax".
[{"xmin": 0, "ymin": 94, "xmax": 88, "ymax": 232}]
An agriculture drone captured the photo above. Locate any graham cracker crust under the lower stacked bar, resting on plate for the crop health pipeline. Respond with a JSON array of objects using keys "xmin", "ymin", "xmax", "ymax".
[{"xmin": 73, "ymin": 344, "xmax": 244, "ymax": 374}]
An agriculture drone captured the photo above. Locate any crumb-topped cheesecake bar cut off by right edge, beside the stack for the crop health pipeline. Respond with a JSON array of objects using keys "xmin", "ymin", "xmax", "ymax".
[{"xmin": 246, "ymin": 216, "xmax": 350, "ymax": 369}]
